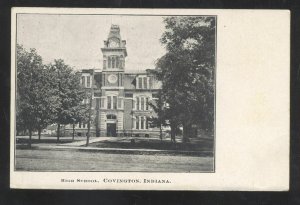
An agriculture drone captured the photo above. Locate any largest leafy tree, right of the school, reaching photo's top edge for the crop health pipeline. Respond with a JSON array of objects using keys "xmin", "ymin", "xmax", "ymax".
[{"xmin": 156, "ymin": 17, "xmax": 215, "ymax": 142}]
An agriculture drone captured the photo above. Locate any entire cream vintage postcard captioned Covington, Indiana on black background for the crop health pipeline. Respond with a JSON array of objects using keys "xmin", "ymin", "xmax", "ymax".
[{"xmin": 10, "ymin": 8, "xmax": 290, "ymax": 191}]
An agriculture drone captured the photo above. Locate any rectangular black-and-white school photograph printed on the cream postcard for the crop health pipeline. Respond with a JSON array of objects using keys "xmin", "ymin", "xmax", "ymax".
[{"xmin": 14, "ymin": 13, "xmax": 217, "ymax": 173}]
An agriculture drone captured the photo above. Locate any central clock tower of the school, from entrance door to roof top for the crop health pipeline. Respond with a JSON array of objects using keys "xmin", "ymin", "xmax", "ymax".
[{"xmin": 100, "ymin": 25, "xmax": 127, "ymax": 136}]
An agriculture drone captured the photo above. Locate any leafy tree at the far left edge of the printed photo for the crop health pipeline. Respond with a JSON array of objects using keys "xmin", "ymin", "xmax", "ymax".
[{"xmin": 16, "ymin": 45, "xmax": 56, "ymax": 146}]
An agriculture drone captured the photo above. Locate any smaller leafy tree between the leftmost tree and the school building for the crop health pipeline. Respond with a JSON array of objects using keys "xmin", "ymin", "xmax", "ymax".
[{"xmin": 48, "ymin": 59, "xmax": 84, "ymax": 142}]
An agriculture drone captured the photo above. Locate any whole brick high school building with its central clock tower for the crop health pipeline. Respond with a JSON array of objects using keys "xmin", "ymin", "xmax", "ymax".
[{"xmin": 66, "ymin": 25, "xmax": 161, "ymax": 136}]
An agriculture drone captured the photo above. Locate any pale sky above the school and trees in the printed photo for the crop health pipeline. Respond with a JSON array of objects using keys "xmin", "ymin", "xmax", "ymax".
[{"xmin": 17, "ymin": 14, "xmax": 165, "ymax": 71}]
